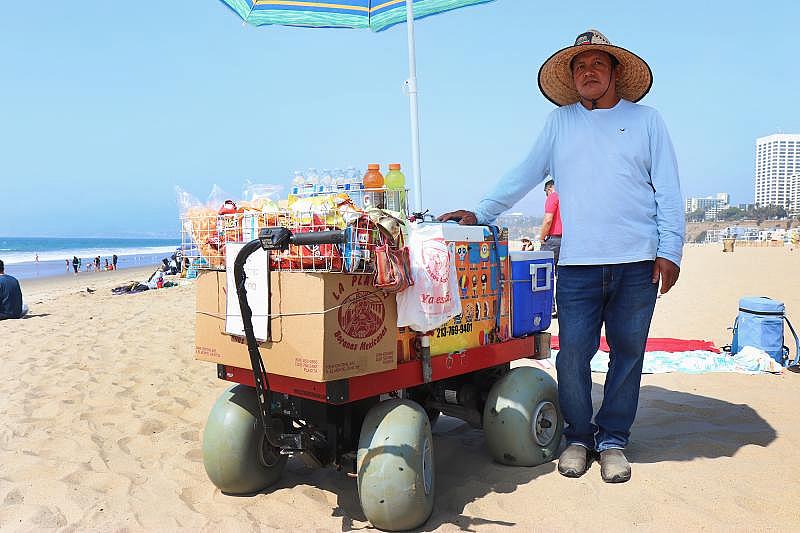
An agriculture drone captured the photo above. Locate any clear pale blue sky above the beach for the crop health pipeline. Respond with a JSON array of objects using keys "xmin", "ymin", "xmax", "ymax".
[{"xmin": 0, "ymin": 0, "xmax": 800, "ymax": 236}]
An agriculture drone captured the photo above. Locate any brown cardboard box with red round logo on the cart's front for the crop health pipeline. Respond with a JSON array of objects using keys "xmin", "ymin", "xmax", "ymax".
[{"xmin": 195, "ymin": 271, "xmax": 398, "ymax": 382}]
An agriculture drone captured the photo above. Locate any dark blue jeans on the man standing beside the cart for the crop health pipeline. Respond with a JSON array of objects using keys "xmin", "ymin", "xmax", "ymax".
[{"xmin": 556, "ymin": 261, "xmax": 658, "ymax": 452}]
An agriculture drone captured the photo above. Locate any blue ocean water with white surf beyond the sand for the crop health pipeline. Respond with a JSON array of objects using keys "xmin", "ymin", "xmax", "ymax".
[{"xmin": 0, "ymin": 237, "xmax": 180, "ymax": 279}]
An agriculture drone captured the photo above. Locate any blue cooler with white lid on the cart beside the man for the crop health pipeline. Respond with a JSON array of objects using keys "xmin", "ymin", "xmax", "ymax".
[{"xmin": 509, "ymin": 252, "xmax": 555, "ymax": 337}]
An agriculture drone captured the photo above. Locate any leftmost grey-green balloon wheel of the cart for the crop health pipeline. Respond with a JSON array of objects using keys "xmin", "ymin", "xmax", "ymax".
[{"xmin": 203, "ymin": 385, "xmax": 286, "ymax": 494}]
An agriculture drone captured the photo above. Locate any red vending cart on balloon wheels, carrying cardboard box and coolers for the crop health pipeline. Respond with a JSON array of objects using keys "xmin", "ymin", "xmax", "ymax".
[{"xmin": 190, "ymin": 203, "xmax": 563, "ymax": 530}]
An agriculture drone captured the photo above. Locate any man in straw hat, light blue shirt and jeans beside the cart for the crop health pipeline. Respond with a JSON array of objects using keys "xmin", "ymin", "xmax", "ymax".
[{"xmin": 439, "ymin": 30, "xmax": 684, "ymax": 483}]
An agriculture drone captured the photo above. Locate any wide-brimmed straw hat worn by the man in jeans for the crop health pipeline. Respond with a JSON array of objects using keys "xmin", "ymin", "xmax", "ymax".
[{"xmin": 539, "ymin": 30, "xmax": 653, "ymax": 106}]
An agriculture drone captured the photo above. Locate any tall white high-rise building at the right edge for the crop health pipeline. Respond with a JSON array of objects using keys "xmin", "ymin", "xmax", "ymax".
[{"xmin": 755, "ymin": 133, "xmax": 800, "ymax": 210}]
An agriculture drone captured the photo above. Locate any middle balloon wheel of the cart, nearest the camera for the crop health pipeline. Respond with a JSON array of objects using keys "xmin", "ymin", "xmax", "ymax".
[{"xmin": 357, "ymin": 399, "xmax": 435, "ymax": 531}]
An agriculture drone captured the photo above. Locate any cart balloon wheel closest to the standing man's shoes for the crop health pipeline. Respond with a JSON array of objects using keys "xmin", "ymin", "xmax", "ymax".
[{"xmin": 483, "ymin": 367, "xmax": 564, "ymax": 466}]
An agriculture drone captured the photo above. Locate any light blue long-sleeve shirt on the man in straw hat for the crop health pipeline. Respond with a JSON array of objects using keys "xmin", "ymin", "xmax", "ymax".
[{"xmin": 475, "ymin": 100, "xmax": 685, "ymax": 265}]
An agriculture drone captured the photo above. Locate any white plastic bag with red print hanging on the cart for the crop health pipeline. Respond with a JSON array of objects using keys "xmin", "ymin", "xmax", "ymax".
[{"xmin": 397, "ymin": 224, "xmax": 461, "ymax": 333}]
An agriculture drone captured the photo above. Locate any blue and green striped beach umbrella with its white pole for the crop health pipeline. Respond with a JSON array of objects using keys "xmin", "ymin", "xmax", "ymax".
[{"xmin": 221, "ymin": 0, "xmax": 493, "ymax": 211}]
